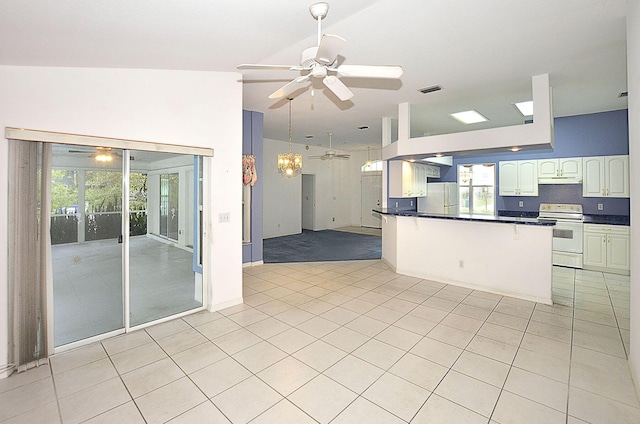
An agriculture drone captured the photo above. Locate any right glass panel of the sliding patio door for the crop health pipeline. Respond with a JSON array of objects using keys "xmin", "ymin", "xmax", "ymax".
[{"xmin": 129, "ymin": 151, "xmax": 202, "ymax": 327}]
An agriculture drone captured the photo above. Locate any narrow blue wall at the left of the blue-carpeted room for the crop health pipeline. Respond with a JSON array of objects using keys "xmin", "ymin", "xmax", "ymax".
[{"xmin": 238, "ymin": 110, "xmax": 264, "ymax": 263}]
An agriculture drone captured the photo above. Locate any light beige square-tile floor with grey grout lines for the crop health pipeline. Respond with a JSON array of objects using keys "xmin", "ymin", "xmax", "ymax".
[{"xmin": 0, "ymin": 261, "xmax": 640, "ymax": 424}]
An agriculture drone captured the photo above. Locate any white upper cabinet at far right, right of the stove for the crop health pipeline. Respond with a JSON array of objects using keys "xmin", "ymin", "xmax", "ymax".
[{"xmin": 582, "ymin": 155, "xmax": 629, "ymax": 197}]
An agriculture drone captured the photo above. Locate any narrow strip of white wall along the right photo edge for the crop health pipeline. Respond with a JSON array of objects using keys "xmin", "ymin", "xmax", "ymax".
[{"xmin": 627, "ymin": 0, "xmax": 640, "ymax": 396}]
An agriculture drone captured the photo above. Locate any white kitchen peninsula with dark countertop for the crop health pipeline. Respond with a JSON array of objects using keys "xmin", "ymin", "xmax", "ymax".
[{"xmin": 374, "ymin": 209, "xmax": 555, "ymax": 305}]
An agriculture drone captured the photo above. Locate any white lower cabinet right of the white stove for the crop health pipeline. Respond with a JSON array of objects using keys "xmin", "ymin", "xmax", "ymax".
[{"xmin": 583, "ymin": 224, "xmax": 630, "ymax": 275}]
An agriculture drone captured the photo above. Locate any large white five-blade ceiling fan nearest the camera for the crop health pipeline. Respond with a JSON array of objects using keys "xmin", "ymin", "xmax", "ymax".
[{"xmin": 238, "ymin": 3, "xmax": 402, "ymax": 101}]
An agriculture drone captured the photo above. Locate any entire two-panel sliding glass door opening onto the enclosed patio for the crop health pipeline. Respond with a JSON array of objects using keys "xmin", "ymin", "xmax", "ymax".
[{"xmin": 51, "ymin": 145, "xmax": 203, "ymax": 347}]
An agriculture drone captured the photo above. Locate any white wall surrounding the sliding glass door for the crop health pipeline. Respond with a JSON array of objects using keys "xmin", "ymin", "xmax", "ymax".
[{"xmin": 0, "ymin": 66, "xmax": 242, "ymax": 376}]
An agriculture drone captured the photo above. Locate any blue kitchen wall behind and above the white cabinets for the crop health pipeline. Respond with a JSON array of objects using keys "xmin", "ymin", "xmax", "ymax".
[{"xmin": 400, "ymin": 109, "xmax": 630, "ymax": 216}]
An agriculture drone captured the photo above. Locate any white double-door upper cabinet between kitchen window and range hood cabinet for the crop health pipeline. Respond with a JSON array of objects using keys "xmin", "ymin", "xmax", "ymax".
[{"xmin": 498, "ymin": 160, "xmax": 538, "ymax": 196}]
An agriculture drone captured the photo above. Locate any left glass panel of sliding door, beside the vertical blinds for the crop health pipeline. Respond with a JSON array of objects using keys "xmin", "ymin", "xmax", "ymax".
[{"xmin": 50, "ymin": 145, "xmax": 124, "ymax": 347}]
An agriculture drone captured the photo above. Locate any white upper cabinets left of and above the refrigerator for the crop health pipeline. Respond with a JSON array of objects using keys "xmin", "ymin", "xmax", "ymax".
[{"xmin": 389, "ymin": 160, "xmax": 440, "ymax": 197}]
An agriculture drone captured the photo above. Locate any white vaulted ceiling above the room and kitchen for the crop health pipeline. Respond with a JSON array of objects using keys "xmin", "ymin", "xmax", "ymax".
[{"xmin": 0, "ymin": 0, "xmax": 627, "ymax": 150}]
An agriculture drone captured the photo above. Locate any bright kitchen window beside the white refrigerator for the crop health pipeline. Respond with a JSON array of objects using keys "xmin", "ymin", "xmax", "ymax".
[{"xmin": 458, "ymin": 163, "xmax": 496, "ymax": 215}]
